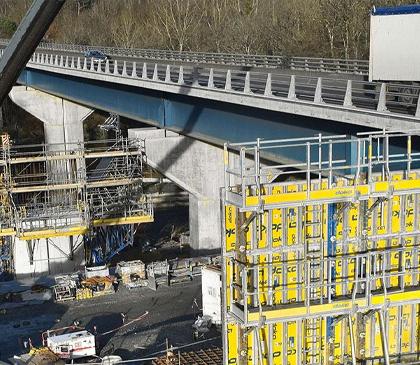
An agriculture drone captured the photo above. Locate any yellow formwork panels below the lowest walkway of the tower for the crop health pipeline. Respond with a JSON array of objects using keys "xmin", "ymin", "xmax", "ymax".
[{"xmin": 227, "ymin": 305, "xmax": 419, "ymax": 365}]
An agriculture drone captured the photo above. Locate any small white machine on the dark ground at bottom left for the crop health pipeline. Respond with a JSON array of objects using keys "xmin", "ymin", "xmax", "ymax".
[{"xmin": 47, "ymin": 331, "xmax": 96, "ymax": 359}]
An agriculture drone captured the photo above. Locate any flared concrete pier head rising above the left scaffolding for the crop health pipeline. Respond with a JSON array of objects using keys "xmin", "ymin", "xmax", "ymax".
[{"xmin": 9, "ymin": 86, "xmax": 93, "ymax": 147}]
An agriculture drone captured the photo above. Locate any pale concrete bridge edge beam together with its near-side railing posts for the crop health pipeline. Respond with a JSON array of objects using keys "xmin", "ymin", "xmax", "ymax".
[{"xmin": 13, "ymin": 45, "xmax": 420, "ymax": 130}]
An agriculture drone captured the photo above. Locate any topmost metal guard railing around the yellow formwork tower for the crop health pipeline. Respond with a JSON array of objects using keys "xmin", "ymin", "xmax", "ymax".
[{"xmin": 225, "ymin": 130, "xmax": 420, "ymax": 209}]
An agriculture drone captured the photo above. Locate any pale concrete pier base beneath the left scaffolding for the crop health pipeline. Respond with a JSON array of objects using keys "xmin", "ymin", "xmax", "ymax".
[{"xmin": 13, "ymin": 236, "xmax": 85, "ymax": 278}]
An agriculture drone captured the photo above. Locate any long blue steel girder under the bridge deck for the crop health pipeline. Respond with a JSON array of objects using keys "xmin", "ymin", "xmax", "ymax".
[{"xmin": 18, "ymin": 68, "xmax": 378, "ymax": 161}]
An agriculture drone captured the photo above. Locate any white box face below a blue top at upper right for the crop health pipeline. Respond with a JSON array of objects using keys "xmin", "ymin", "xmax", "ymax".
[{"xmin": 369, "ymin": 7, "xmax": 420, "ymax": 82}]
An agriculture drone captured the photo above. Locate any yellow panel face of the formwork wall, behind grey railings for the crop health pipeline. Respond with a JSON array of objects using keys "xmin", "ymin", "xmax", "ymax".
[{"xmin": 225, "ymin": 174, "xmax": 420, "ymax": 365}]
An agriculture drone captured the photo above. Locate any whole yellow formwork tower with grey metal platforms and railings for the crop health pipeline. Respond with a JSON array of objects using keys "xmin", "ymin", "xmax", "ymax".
[{"xmin": 223, "ymin": 132, "xmax": 420, "ymax": 365}]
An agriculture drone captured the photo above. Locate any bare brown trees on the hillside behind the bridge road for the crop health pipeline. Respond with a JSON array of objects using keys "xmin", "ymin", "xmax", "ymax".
[{"xmin": 0, "ymin": 0, "xmax": 420, "ymax": 58}]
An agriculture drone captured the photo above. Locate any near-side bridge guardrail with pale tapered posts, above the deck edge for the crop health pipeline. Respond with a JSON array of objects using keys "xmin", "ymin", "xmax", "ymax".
[{"xmin": 18, "ymin": 48, "xmax": 420, "ymax": 121}]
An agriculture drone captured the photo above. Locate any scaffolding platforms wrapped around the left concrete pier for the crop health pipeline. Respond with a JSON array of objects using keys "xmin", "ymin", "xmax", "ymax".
[{"xmin": 0, "ymin": 137, "xmax": 153, "ymax": 268}]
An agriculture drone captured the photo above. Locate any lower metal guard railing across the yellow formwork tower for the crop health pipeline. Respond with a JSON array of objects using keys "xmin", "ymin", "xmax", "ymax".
[{"xmin": 229, "ymin": 246, "xmax": 420, "ymax": 324}]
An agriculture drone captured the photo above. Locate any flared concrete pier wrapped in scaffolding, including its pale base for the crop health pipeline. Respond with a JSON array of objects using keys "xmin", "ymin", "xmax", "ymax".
[{"xmin": 10, "ymin": 86, "xmax": 93, "ymax": 278}]
